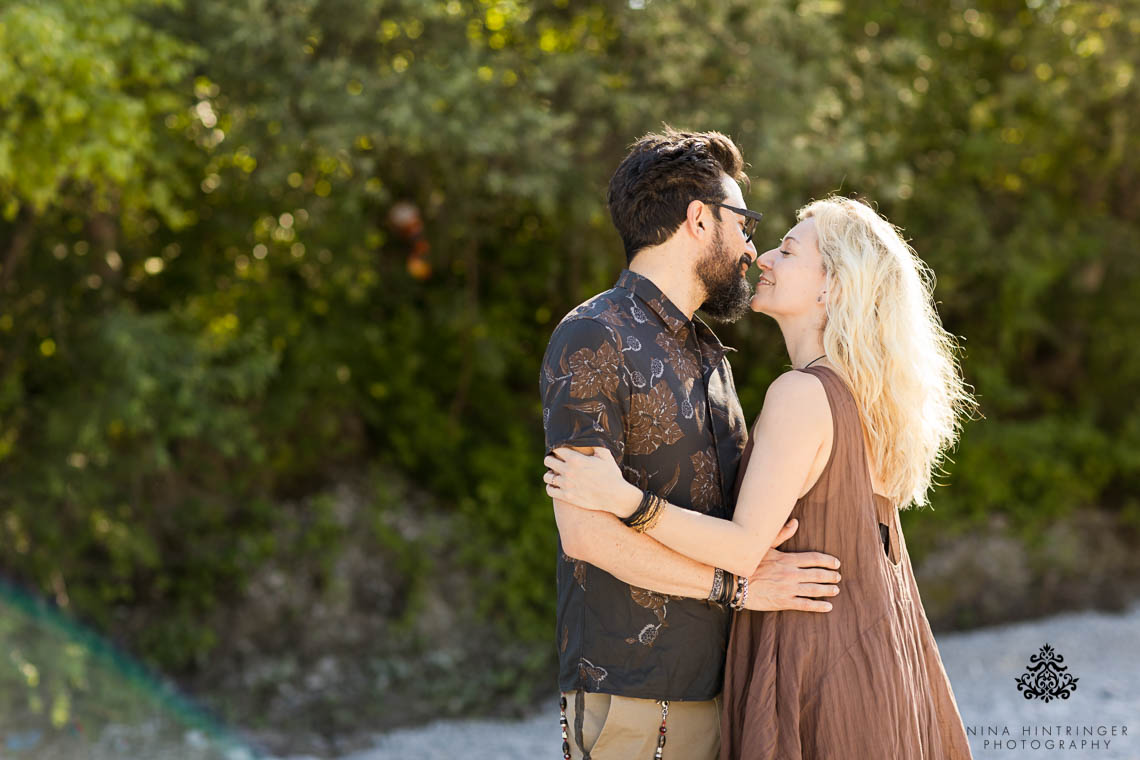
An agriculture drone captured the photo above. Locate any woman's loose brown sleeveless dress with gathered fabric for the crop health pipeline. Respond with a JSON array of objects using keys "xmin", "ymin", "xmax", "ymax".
[{"xmin": 720, "ymin": 367, "xmax": 970, "ymax": 760}]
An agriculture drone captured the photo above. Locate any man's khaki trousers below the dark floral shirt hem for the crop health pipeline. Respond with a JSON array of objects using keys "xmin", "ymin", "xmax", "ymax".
[{"xmin": 564, "ymin": 692, "xmax": 720, "ymax": 760}]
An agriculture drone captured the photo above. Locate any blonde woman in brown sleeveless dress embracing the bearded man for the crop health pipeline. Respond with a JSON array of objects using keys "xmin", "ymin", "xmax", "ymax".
[{"xmin": 546, "ymin": 197, "xmax": 974, "ymax": 760}]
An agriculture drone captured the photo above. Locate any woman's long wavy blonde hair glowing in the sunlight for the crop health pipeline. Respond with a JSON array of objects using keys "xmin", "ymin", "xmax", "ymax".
[{"xmin": 798, "ymin": 196, "xmax": 977, "ymax": 508}]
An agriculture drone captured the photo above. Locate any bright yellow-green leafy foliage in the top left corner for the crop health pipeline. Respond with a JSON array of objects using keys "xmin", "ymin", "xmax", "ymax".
[{"xmin": 0, "ymin": 0, "xmax": 195, "ymax": 226}]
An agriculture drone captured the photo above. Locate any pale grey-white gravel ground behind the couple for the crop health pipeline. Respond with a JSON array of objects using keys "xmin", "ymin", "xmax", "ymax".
[{"xmin": 319, "ymin": 604, "xmax": 1140, "ymax": 760}]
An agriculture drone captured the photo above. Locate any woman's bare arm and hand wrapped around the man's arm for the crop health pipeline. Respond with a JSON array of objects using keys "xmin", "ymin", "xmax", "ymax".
[{"xmin": 547, "ymin": 371, "xmax": 831, "ymax": 577}]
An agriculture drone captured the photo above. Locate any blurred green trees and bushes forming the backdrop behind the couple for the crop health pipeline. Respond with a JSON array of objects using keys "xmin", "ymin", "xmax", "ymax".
[{"xmin": 0, "ymin": 0, "xmax": 1140, "ymax": 747}]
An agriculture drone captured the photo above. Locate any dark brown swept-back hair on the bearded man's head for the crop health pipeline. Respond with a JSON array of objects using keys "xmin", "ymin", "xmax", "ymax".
[{"xmin": 606, "ymin": 124, "xmax": 748, "ymax": 262}]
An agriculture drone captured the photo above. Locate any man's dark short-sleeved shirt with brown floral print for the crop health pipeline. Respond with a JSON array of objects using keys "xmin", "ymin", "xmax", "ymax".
[{"xmin": 539, "ymin": 270, "xmax": 748, "ymax": 700}]
